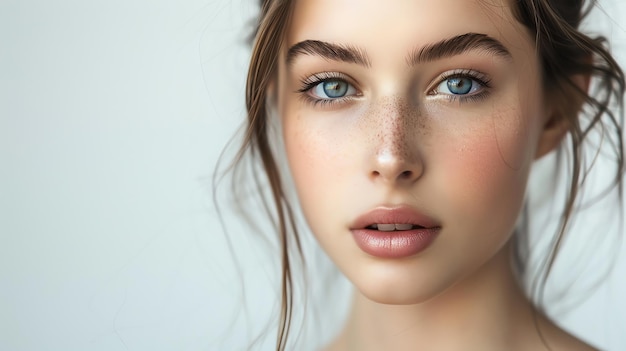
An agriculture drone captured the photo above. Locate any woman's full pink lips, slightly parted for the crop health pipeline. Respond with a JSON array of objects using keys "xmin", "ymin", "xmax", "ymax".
[{"xmin": 350, "ymin": 206, "xmax": 441, "ymax": 258}]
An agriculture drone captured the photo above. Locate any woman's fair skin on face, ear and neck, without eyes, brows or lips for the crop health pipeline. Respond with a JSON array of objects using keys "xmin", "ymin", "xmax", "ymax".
[{"xmin": 275, "ymin": 0, "xmax": 592, "ymax": 351}]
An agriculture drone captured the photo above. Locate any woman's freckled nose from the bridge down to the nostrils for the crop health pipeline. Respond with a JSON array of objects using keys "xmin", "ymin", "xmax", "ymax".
[{"xmin": 370, "ymin": 98, "xmax": 423, "ymax": 181}]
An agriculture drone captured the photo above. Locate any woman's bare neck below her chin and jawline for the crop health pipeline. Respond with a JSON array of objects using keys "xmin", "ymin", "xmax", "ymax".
[{"xmin": 330, "ymin": 243, "xmax": 540, "ymax": 351}]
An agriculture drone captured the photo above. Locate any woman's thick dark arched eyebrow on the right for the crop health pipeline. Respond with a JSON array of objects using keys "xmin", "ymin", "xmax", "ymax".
[{"xmin": 406, "ymin": 33, "xmax": 513, "ymax": 66}]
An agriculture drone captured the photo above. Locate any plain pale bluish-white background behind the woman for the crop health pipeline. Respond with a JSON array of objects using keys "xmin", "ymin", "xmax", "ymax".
[{"xmin": 0, "ymin": 0, "xmax": 626, "ymax": 351}]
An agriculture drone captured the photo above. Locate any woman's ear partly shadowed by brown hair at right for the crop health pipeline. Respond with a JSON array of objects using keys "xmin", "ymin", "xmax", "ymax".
[{"xmin": 535, "ymin": 74, "xmax": 590, "ymax": 159}]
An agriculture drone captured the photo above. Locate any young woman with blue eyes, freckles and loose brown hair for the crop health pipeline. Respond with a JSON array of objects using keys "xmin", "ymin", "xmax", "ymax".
[{"xmin": 222, "ymin": 0, "xmax": 624, "ymax": 350}]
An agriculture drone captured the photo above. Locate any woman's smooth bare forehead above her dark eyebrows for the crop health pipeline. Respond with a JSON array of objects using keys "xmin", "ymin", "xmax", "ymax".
[{"xmin": 286, "ymin": 0, "xmax": 531, "ymax": 55}]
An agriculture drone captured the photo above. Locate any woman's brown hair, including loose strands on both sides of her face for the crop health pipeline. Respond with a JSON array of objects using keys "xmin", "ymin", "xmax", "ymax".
[{"xmin": 219, "ymin": 0, "xmax": 625, "ymax": 350}]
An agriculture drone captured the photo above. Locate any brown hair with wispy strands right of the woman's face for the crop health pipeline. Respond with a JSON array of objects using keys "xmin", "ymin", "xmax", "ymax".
[{"xmin": 515, "ymin": 0, "xmax": 625, "ymax": 300}]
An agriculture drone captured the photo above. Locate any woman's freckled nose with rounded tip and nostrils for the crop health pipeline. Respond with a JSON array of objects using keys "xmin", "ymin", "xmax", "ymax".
[{"xmin": 369, "ymin": 102, "xmax": 424, "ymax": 184}]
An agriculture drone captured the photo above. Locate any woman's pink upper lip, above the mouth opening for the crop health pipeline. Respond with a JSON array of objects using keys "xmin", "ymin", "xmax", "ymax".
[{"xmin": 350, "ymin": 205, "xmax": 440, "ymax": 229}]
